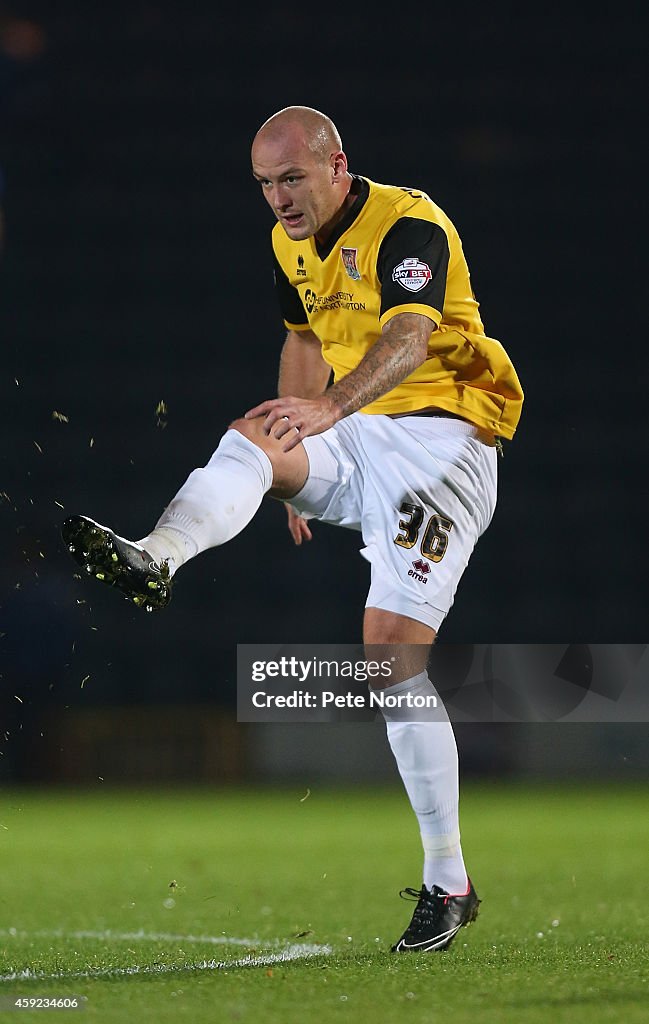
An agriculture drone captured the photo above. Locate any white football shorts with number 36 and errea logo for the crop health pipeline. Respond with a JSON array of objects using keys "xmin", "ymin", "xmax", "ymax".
[{"xmin": 291, "ymin": 413, "xmax": 497, "ymax": 631}]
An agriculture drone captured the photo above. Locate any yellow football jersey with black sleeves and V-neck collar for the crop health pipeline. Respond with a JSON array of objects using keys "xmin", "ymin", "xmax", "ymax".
[{"xmin": 272, "ymin": 176, "xmax": 523, "ymax": 438}]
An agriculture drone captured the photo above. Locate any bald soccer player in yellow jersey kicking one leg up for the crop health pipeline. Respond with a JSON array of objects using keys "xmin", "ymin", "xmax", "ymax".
[{"xmin": 62, "ymin": 106, "xmax": 523, "ymax": 952}]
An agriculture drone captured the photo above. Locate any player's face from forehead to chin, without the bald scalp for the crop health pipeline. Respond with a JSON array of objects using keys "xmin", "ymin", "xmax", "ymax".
[{"xmin": 252, "ymin": 133, "xmax": 341, "ymax": 242}]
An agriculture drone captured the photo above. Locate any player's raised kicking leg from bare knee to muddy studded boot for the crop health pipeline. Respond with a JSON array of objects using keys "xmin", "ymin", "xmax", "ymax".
[{"xmin": 61, "ymin": 417, "xmax": 309, "ymax": 610}]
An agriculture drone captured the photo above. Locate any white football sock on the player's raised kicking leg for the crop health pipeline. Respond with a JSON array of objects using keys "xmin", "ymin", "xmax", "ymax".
[{"xmin": 137, "ymin": 429, "xmax": 272, "ymax": 575}]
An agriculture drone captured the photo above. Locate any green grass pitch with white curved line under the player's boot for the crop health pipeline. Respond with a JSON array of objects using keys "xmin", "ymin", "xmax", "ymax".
[{"xmin": 0, "ymin": 784, "xmax": 649, "ymax": 1024}]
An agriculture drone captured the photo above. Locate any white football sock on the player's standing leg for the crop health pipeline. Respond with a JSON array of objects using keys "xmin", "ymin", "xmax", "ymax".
[{"xmin": 382, "ymin": 672, "xmax": 469, "ymax": 894}]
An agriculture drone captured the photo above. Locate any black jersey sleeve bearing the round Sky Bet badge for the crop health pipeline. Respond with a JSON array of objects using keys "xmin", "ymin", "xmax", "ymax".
[{"xmin": 377, "ymin": 217, "xmax": 449, "ymax": 316}]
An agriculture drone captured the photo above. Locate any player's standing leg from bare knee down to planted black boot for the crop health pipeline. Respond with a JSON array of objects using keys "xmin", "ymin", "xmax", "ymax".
[{"xmin": 363, "ymin": 607, "xmax": 480, "ymax": 952}]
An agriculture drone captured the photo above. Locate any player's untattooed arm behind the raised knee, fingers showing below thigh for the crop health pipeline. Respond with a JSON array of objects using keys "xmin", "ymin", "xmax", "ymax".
[{"xmin": 277, "ymin": 331, "xmax": 332, "ymax": 546}]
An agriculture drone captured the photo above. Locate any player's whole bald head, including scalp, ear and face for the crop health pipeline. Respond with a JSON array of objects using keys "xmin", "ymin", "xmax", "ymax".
[{"xmin": 252, "ymin": 106, "xmax": 352, "ymax": 242}]
